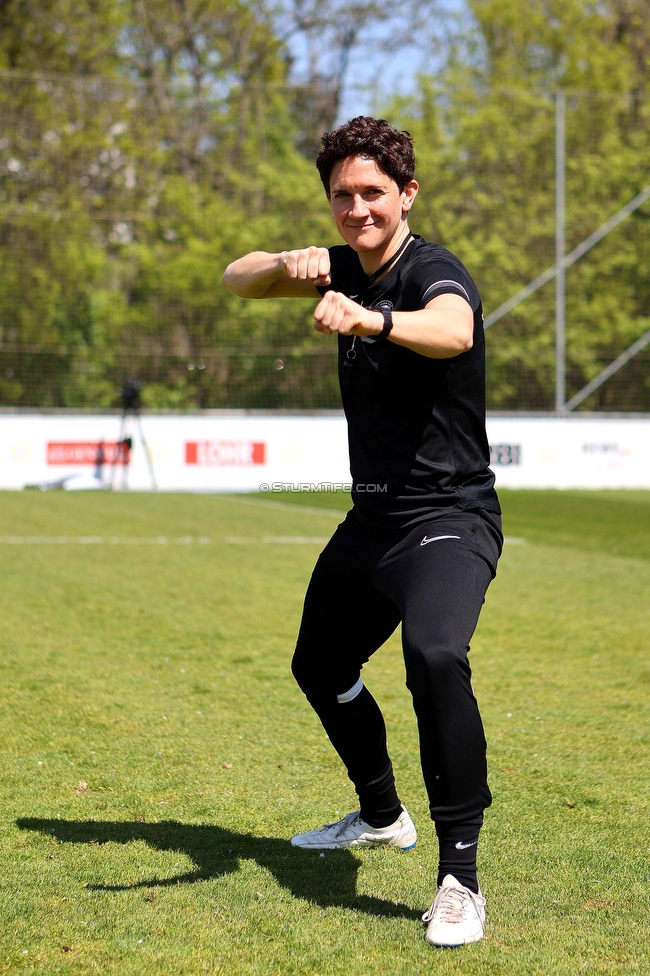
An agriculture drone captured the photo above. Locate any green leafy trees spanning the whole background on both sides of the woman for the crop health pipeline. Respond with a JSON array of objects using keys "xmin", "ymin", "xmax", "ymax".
[{"xmin": 0, "ymin": 0, "xmax": 650, "ymax": 410}]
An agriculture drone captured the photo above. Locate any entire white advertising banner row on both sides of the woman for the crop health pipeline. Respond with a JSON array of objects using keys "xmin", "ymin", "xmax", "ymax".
[{"xmin": 0, "ymin": 412, "xmax": 650, "ymax": 495}]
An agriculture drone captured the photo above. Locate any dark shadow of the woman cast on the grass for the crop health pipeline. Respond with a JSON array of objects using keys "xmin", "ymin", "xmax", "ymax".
[{"xmin": 16, "ymin": 817, "xmax": 420, "ymax": 919}]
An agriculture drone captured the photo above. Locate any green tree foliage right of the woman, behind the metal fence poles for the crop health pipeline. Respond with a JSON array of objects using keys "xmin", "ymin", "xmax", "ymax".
[{"xmin": 384, "ymin": 0, "xmax": 650, "ymax": 409}]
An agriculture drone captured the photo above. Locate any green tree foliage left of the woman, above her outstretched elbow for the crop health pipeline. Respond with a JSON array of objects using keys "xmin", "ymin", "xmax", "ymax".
[{"xmin": 0, "ymin": 0, "xmax": 340, "ymax": 407}]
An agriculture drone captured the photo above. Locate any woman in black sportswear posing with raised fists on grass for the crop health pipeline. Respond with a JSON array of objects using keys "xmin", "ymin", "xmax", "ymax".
[{"xmin": 223, "ymin": 116, "xmax": 502, "ymax": 946}]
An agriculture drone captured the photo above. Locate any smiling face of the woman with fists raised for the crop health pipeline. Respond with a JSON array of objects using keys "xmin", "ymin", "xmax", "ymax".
[{"xmin": 329, "ymin": 156, "xmax": 418, "ymax": 271}]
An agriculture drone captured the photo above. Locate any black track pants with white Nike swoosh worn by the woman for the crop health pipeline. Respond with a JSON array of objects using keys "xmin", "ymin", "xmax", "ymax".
[{"xmin": 292, "ymin": 510, "xmax": 502, "ymax": 822}]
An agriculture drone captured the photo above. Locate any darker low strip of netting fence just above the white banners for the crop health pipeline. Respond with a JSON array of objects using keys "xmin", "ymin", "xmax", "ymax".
[{"xmin": 0, "ymin": 343, "xmax": 650, "ymax": 413}]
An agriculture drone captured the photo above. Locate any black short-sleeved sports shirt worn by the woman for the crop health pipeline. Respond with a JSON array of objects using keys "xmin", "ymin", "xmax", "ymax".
[{"xmin": 319, "ymin": 235, "xmax": 500, "ymax": 528}]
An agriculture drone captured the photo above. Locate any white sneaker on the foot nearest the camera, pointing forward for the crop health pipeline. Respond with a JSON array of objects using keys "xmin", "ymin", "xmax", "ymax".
[{"xmin": 422, "ymin": 874, "xmax": 485, "ymax": 947}]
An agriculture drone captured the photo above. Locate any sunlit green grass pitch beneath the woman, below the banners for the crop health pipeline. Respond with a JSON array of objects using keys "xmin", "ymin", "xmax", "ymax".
[{"xmin": 0, "ymin": 491, "xmax": 650, "ymax": 976}]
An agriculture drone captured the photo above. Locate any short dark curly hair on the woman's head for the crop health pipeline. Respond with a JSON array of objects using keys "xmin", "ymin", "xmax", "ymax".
[{"xmin": 316, "ymin": 115, "xmax": 415, "ymax": 196}]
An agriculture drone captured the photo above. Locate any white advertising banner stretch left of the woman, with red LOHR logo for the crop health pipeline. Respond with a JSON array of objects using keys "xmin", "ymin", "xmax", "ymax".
[{"xmin": 0, "ymin": 413, "xmax": 350, "ymax": 491}]
